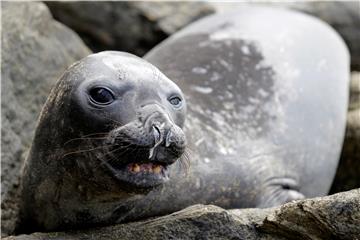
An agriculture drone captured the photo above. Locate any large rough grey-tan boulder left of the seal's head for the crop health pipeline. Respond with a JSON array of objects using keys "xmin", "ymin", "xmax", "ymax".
[{"xmin": 1, "ymin": 2, "xmax": 90, "ymax": 235}]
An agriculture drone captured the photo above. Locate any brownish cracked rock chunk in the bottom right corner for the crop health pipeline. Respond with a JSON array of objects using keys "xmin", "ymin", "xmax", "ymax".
[{"xmin": 259, "ymin": 189, "xmax": 360, "ymax": 239}]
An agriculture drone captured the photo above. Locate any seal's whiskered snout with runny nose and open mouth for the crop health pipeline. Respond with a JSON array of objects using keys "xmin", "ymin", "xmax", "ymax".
[{"xmin": 101, "ymin": 108, "xmax": 186, "ymax": 188}]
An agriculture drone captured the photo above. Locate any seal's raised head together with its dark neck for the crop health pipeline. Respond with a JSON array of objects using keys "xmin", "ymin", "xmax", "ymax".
[{"xmin": 19, "ymin": 51, "xmax": 186, "ymax": 232}]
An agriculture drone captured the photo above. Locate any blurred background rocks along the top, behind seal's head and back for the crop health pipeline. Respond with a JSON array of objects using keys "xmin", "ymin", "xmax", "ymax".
[{"xmin": 46, "ymin": 0, "xmax": 360, "ymax": 70}]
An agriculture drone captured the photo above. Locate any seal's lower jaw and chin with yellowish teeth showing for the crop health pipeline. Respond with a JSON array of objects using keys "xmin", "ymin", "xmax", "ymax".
[{"xmin": 102, "ymin": 162, "xmax": 169, "ymax": 188}]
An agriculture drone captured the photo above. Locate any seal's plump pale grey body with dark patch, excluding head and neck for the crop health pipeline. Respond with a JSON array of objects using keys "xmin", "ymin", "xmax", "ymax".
[{"xmin": 140, "ymin": 6, "xmax": 349, "ymax": 212}]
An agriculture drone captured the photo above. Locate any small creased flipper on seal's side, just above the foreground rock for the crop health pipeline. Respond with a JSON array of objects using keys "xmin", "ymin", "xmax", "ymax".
[{"xmin": 256, "ymin": 177, "xmax": 305, "ymax": 208}]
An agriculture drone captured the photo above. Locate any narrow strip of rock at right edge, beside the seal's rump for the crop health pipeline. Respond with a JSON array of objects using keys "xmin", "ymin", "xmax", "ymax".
[{"xmin": 331, "ymin": 72, "xmax": 360, "ymax": 193}]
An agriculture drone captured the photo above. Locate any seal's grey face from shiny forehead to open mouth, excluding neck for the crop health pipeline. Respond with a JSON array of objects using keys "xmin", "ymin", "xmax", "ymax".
[{"xmin": 69, "ymin": 52, "xmax": 186, "ymax": 187}]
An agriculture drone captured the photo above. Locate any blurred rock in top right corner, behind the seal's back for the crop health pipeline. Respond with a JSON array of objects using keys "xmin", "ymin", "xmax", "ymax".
[{"xmin": 212, "ymin": 1, "xmax": 360, "ymax": 70}]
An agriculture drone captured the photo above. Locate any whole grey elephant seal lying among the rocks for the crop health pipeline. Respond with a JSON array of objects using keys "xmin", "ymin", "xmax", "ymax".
[{"xmin": 17, "ymin": 6, "xmax": 349, "ymax": 234}]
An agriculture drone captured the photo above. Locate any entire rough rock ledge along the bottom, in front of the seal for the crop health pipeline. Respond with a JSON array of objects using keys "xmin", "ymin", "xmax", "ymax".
[{"xmin": 6, "ymin": 189, "xmax": 360, "ymax": 240}]
